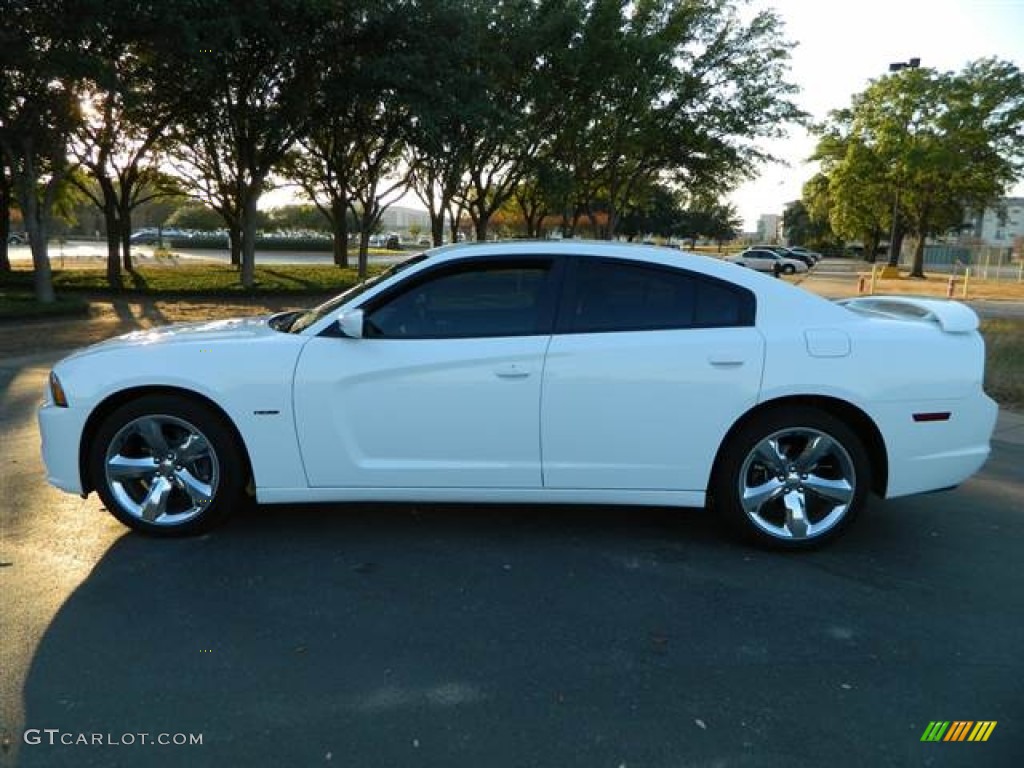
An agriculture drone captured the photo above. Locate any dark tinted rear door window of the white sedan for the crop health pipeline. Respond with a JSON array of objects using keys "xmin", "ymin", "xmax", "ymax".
[{"xmin": 559, "ymin": 258, "xmax": 755, "ymax": 333}]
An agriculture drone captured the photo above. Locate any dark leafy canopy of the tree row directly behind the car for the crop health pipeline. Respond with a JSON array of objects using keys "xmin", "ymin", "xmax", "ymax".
[{"xmin": 6, "ymin": 0, "xmax": 806, "ymax": 294}]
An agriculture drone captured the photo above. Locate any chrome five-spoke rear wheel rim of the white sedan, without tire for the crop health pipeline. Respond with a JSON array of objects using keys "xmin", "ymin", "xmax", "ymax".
[{"xmin": 738, "ymin": 427, "xmax": 857, "ymax": 540}]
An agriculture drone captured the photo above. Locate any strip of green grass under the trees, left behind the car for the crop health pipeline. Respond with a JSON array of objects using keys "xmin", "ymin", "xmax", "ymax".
[{"xmin": 0, "ymin": 264, "xmax": 379, "ymax": 297}]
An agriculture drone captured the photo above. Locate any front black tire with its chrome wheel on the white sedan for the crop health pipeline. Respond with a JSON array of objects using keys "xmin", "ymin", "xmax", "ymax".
[{"xmin": 88, "ymin": 394, "xmax": 249, "ymax": 537}]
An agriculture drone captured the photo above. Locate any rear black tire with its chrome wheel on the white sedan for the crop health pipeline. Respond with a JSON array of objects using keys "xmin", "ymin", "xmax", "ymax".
[{"xmin": 712, "ymin": 406, "xmax": 871, "ymax": 550}]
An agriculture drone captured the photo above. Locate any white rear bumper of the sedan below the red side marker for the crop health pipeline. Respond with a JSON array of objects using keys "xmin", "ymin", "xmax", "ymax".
[{"xmin": 874, "ymin": 393, "xmax": 998, "ymax": 499}]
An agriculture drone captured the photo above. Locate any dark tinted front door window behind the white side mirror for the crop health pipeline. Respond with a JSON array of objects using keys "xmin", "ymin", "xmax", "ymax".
[{"xmin": 366, "ymin": 261, "xmax": 551, "ymax": 339}]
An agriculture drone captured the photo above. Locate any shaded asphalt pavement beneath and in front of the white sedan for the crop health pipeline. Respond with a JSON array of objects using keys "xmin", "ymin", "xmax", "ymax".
[{"xmin": 0, "ymin": 354, "xmax": 1024, "ymax": 768}]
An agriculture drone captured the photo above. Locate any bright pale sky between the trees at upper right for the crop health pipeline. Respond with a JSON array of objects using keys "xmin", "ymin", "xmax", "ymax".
[{"xmin": 730, "ymin": 0, "xmax": 1024, "ymax": 231}]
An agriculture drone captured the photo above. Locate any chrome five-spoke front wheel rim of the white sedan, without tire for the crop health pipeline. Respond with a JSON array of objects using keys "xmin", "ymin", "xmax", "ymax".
[{"xmin": 103, "ymin": 415, "xmax": 220, "ymax": 525}]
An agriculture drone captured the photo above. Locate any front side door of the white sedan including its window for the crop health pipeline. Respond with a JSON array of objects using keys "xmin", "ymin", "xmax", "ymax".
[{"xmin": 294, "ymin": 258, "xmax": 554, "ymax": 487}]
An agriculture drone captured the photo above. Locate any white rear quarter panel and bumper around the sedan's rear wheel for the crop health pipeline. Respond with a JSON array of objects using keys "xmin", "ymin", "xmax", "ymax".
[{"xmin": 761, "ymin": 307, "xmax": 997, "ymax": 498}]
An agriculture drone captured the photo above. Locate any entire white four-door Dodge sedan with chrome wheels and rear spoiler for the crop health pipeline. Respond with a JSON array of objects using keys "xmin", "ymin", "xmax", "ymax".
[{"xmin": 39, "ymin": 242, "xmax": 996, "ymax": 548}]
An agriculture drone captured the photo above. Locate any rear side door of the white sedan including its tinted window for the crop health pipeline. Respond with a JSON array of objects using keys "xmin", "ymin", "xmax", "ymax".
[{"xmin": 541, "ymin": 257, "xmax": 764, "ymax": 490}]
